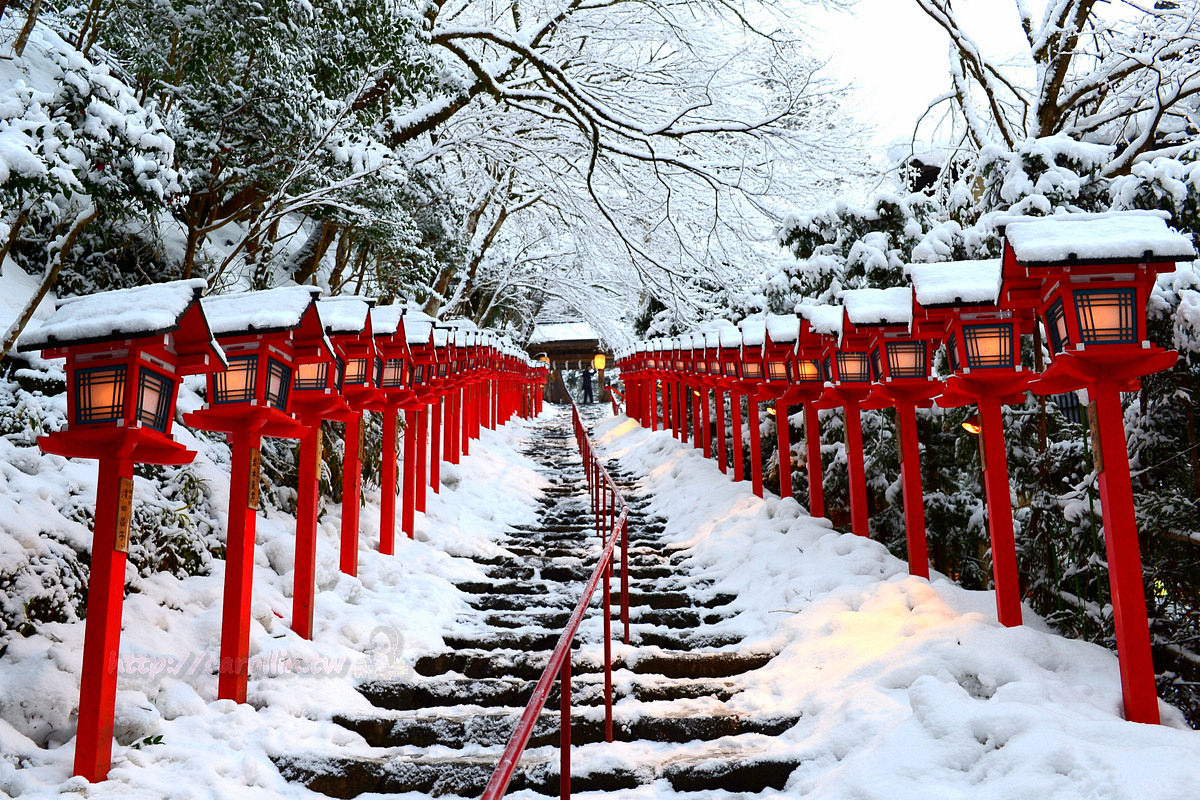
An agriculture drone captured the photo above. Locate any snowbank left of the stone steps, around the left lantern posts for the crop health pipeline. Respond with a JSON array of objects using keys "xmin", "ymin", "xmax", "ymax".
[{"xmin": 0, "ymin": 389, "xmax": 545, "ymax": 800}]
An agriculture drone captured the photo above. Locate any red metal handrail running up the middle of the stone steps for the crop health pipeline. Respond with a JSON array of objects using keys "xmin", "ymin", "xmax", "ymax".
[{"xmin": 482, "ymin": 403, "xmax": 629, "ymax": 800}]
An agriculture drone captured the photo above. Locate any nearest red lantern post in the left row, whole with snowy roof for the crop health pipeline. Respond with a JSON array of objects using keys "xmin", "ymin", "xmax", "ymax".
[{"xmin": 19, "ymin": 281, "xmax": 224, "ymax": 782}]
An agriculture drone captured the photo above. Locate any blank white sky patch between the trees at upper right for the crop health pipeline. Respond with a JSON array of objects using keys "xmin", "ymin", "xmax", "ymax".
[{"xmin": 810, "ymin": 0, "xmax": 1040, "ymax": 146}]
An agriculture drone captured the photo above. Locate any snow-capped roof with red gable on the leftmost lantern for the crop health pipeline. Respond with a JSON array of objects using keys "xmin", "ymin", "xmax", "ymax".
[{"xmin": 17, "ymin": 279, "xmax": 224, "ymax": 372}]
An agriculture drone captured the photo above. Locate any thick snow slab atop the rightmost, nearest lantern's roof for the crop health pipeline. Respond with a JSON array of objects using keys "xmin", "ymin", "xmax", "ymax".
[{"xmin": 1004, "ymin": 211, "xmax": 1195, "ymax": 264}]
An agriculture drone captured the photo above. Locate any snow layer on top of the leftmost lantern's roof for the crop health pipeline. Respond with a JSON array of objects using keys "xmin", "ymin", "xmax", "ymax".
[{"xmin": 19, "ymin": 279, "xmax": 207, "ymax": 350}]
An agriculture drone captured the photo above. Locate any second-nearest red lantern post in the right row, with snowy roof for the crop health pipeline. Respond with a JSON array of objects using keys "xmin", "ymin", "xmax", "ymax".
[{"xmin": 906, "ymin": 259, "xmax": 1033, "ymax": 626}]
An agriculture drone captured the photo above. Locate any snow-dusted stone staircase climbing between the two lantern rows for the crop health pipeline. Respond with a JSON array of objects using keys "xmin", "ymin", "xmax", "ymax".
[{"xmin": 276, "ymin": 405, "xmax": 799, "ymax": 798}]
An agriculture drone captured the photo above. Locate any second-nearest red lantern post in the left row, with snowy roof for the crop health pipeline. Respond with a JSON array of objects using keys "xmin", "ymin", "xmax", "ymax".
[{"xmin": 184, "ymin": 287, "xmax": 332, "ymax": 703}]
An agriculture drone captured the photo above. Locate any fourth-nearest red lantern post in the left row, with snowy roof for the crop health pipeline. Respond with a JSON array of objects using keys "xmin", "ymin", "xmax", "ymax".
[{"xmin": 317, "ymin": 297, "xmax": 379, "ymax": 576}]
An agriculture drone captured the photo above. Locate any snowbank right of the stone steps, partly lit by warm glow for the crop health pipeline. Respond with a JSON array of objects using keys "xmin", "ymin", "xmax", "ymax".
[{"xmin": 596, "ymin": 417, "xmax": 1200, "ymax": 800}]
